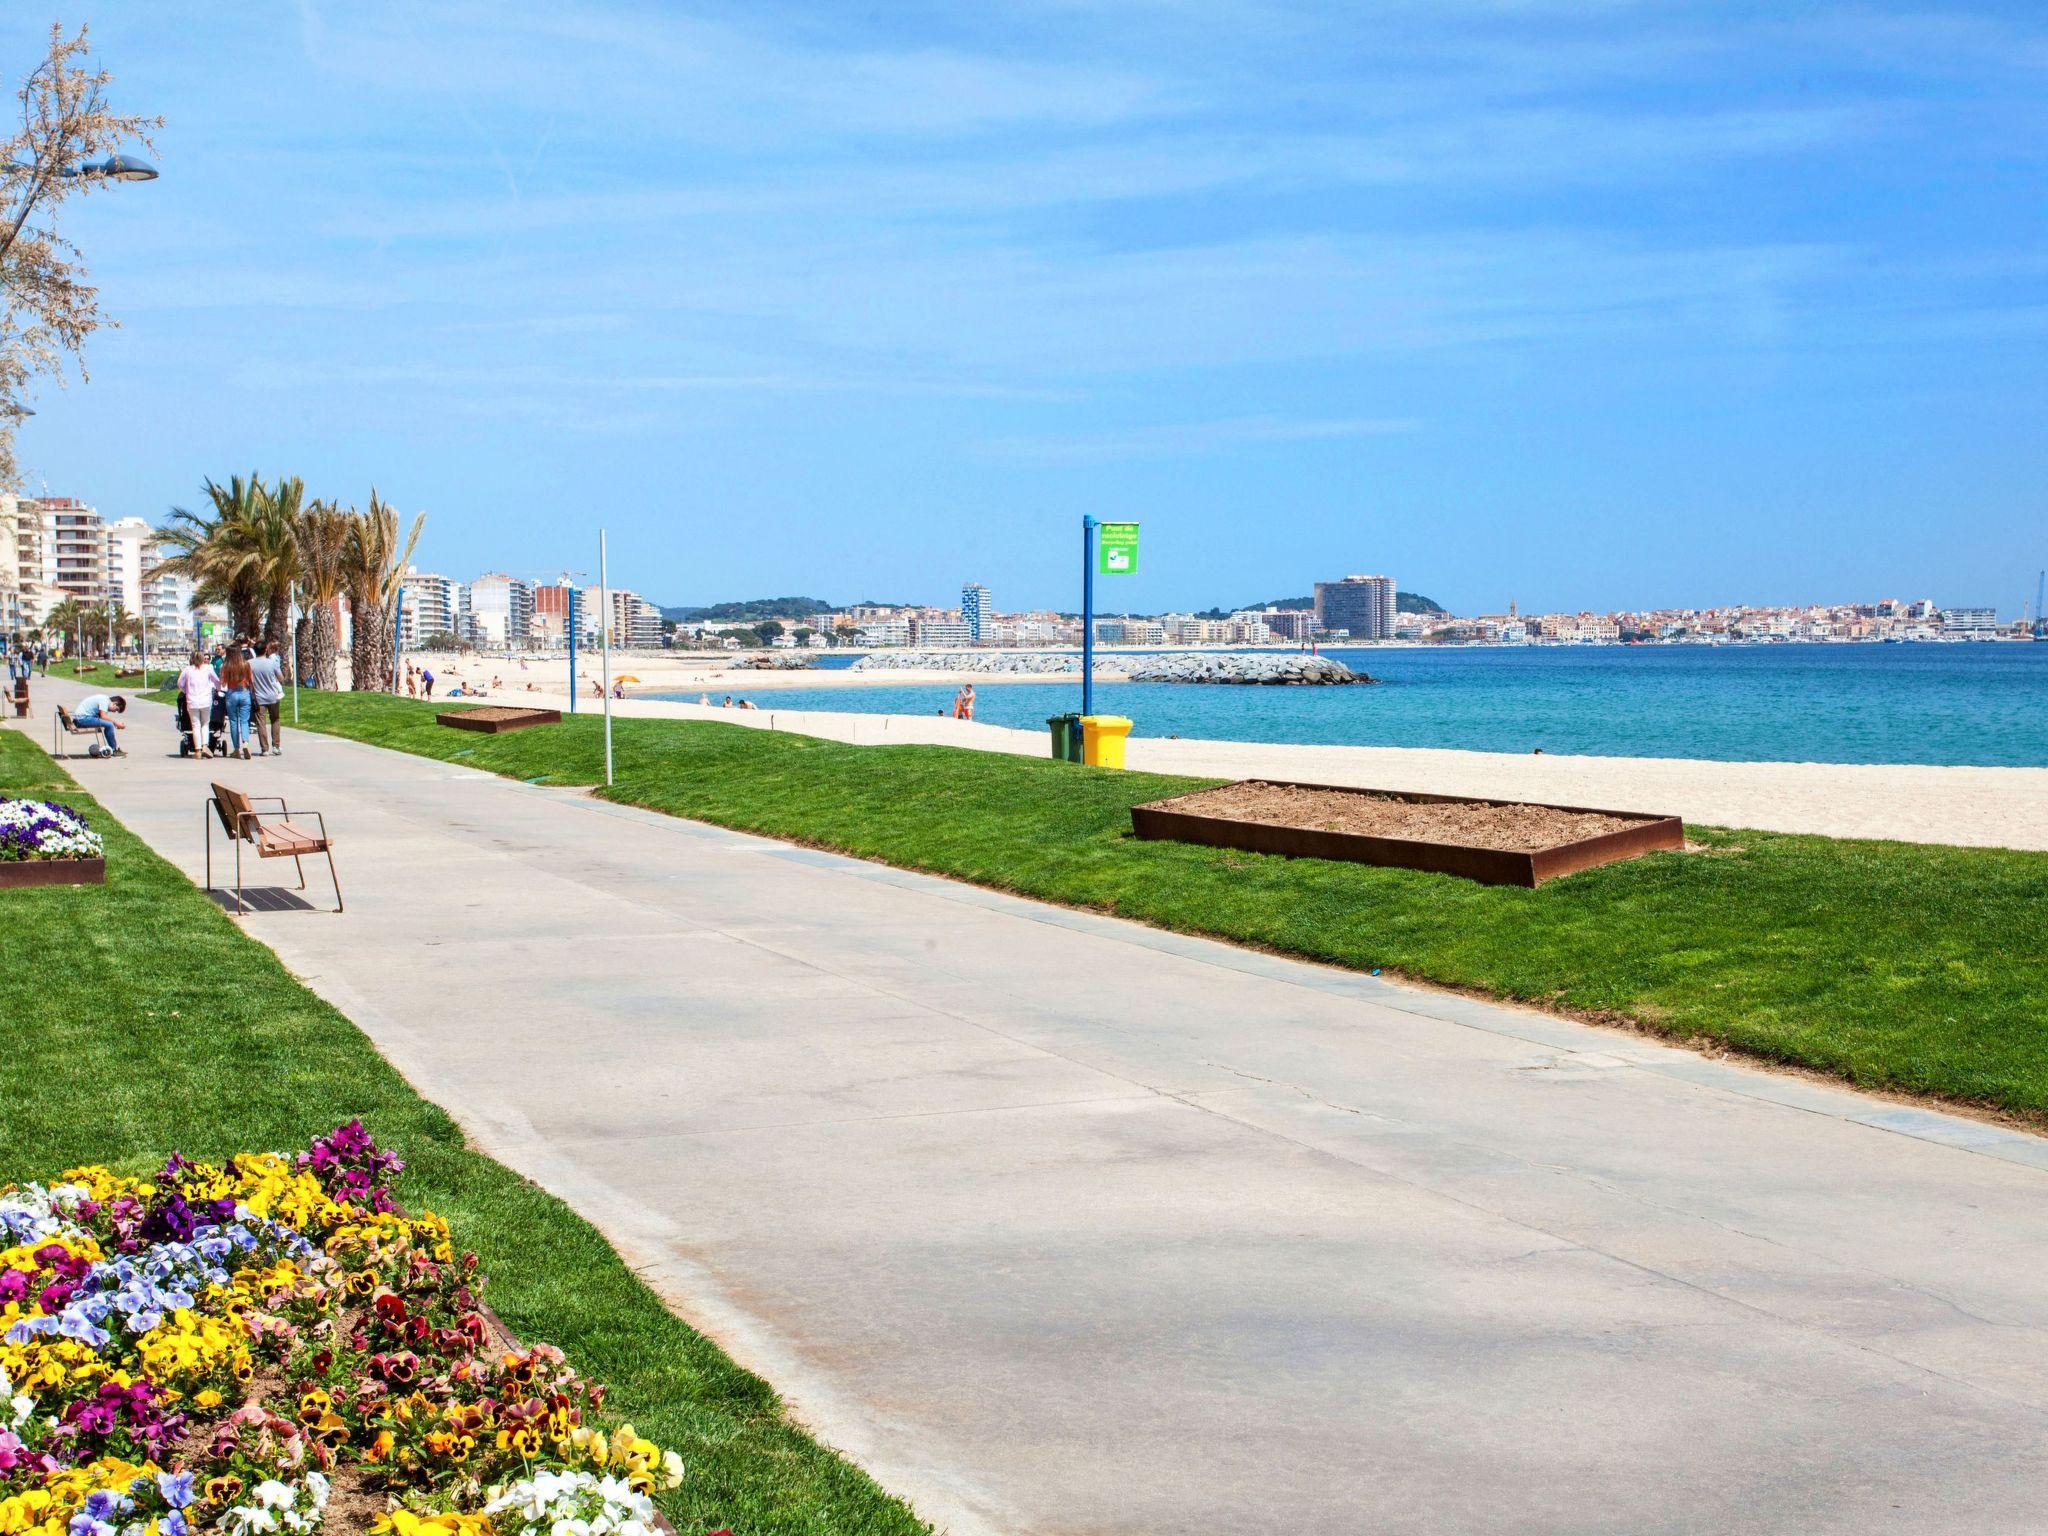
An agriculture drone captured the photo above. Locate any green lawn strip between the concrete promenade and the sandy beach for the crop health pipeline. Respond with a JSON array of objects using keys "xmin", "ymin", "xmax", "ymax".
[{"xmin": 251, "ymin": 692, "xmax": 2048, "ymax": 1124}]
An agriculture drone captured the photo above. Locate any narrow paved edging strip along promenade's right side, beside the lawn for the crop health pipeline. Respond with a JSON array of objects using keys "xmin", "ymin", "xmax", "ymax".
[{"xmin": 48, "ymin": 705, "xmax": 2048, "ymax": 1171}]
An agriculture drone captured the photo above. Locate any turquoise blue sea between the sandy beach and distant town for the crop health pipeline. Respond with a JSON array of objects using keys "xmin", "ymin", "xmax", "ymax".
[{"xmin": 655, "ymin": 643, "xmax": 2048, "ymax": 768}]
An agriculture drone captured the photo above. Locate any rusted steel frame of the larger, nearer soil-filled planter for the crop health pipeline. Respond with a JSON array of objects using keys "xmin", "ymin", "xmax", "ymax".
[{"xmin": 1130, "ymin": 778, "xmax": 1686, "ymax": 887}]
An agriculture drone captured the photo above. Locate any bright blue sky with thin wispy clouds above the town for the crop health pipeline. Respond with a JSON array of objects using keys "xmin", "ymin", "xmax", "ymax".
[{"xmin": 12, "ymin": 0, "xmax": 2048, "ymax": 612}]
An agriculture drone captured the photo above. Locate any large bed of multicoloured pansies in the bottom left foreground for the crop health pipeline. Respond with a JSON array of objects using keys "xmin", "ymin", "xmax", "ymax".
[{"xmin": 0, "ymin": 1122, "xmax": 682, "ymax": 1536}]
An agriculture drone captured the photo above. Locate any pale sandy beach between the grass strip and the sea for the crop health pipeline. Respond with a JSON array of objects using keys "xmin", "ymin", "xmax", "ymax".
[{"xmin": 387, "ymin": 655, "xmax": 2048, "ymax": 850}]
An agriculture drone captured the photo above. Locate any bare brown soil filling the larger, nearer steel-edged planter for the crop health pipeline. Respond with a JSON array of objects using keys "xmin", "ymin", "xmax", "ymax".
[{"xmin": 1174, "ymin": 784, "xmax": 1642, "ymax": 854}]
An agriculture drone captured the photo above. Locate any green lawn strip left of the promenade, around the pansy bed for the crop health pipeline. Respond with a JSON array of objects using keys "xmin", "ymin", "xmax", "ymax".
[{"xmin": 0, "ymin": 723, "xmax": 926, "ymax": 1536}]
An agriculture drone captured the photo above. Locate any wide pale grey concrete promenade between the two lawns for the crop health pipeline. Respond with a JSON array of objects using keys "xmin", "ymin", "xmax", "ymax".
[{"xmin": 27, "ymin": 680, "xmax": 2048, "ymax": 1536}]
